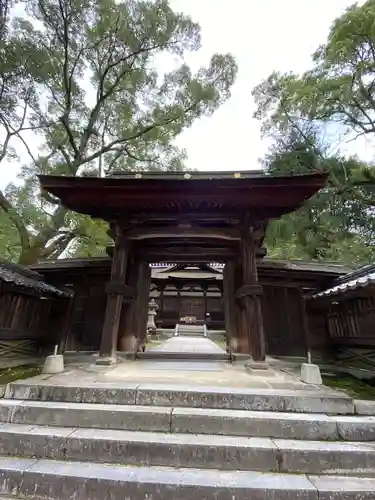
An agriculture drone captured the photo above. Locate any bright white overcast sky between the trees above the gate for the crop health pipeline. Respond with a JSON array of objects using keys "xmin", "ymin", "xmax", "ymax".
[{"xmin": 0, "ymin": 0, "xmax": 372, "ymax": 187}]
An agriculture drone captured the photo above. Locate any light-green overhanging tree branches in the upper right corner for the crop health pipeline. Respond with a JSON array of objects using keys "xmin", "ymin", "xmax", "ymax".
[{"xmin": 253, "ymin": 0, "xmax": 375, "ymax": 139}]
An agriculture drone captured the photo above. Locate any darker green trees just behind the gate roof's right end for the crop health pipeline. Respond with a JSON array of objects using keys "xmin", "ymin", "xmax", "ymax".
[{"xmin": 264, "ymin": 133, "xmax": 375, "ymax": 266}]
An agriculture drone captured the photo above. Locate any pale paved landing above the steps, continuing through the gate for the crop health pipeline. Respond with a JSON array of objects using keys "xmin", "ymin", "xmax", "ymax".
[{"xmin": 36, "ymin": 336, "xmax": 340, "ymax": 391}]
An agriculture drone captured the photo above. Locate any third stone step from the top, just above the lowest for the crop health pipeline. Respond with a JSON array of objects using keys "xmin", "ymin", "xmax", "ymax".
[{"xmin": 0, "ymin": 424, "xmax": 375, "ymax": 476}]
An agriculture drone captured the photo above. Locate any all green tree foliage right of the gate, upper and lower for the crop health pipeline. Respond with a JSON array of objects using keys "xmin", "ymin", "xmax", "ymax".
[{"xmin": 253, "ymin": 0, "xmax": 375, "ymax": 265}]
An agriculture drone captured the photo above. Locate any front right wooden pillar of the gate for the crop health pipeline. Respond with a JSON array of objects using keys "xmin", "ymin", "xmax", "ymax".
[{"xmin": 236, "ymin": 227, "xmax": 266, "ymax": 363}]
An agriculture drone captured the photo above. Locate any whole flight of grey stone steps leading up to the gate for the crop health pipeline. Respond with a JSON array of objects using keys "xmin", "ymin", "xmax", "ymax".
[{"xmin": 0, "ymin": 378, "xmax": 375, "ymax": 500}]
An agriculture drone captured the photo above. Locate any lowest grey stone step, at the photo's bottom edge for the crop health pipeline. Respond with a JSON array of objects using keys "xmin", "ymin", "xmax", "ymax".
[{"xmin": 0, "ymin": 458, "xmax": 375, "ymax": 500}]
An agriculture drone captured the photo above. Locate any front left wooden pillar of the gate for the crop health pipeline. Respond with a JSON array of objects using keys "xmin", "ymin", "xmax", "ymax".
[{"xmin": 97, "ymin": 227, "xmax": 129, "ymax": 364}]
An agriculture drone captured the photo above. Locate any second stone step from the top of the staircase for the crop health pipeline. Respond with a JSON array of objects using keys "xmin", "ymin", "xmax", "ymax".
[{"xmin": 0, "ymin": 399, "xmax": 375, "ymax": 441}]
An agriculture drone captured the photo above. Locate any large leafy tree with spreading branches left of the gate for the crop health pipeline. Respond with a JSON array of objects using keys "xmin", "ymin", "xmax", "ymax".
[{"xmin": 0, "ymin": 0, "xmax": 237, "ymax": 264}]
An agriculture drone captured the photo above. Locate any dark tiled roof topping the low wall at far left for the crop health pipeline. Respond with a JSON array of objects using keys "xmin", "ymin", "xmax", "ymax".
[{"xmin": 0, "ymin": 261, "xmax": 72, "ymax": 297}]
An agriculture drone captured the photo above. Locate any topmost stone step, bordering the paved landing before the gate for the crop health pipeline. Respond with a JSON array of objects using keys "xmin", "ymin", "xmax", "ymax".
[{"xmin": 5, "ymin": 382, "xmax": 354, "ymax": 415}]
